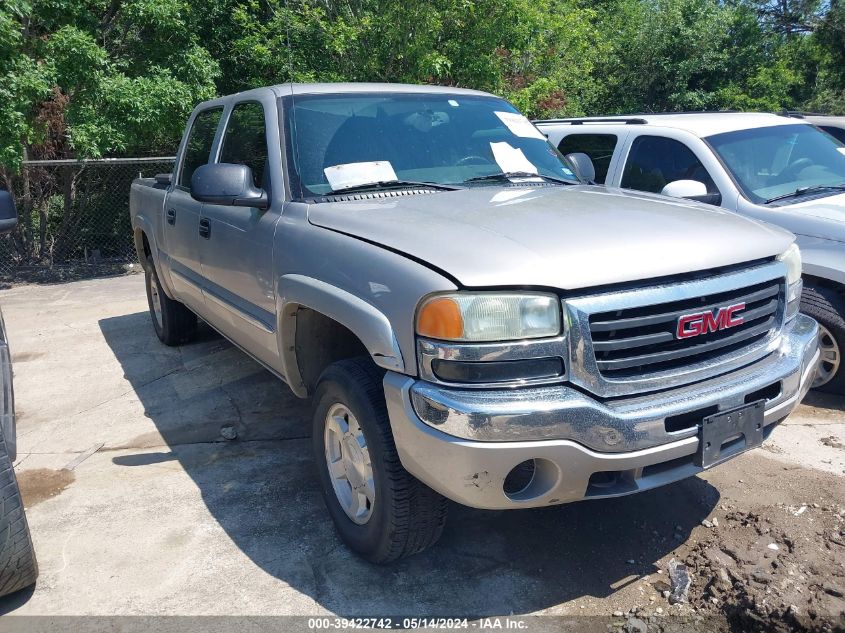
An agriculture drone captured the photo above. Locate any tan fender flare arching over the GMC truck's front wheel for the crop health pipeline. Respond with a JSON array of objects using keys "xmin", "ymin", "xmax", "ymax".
[{"xmin": 277, "ymin": 274, "xmax": 405, "ymax": 391}]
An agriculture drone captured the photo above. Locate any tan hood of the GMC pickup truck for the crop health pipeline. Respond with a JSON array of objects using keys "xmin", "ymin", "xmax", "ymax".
[{"xmin": 308, "ymin": 186, "xmax": 793, "ymax": 290}]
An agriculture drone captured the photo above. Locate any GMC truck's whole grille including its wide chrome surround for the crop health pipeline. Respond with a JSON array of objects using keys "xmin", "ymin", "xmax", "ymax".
[{"xmin": 563, "ymin": 260, "xmax": 786, "ymax": 397}]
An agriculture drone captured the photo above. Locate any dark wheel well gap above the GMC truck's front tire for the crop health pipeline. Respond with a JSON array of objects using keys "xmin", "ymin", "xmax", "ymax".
[{"xmin": 294, "ymin": 307, "xmax": 370, "ymax": 395}]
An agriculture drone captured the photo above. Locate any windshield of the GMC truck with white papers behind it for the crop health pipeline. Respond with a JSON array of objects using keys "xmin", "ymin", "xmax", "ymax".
[{"xmin": 285, "ymin": 93, "xmax": 578, "ymax": 198}]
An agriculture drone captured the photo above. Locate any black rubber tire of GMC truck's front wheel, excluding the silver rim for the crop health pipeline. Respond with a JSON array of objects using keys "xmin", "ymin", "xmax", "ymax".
[{"xmin": 312, "ymin": 358, "xmax": 447, "ymax": 563}]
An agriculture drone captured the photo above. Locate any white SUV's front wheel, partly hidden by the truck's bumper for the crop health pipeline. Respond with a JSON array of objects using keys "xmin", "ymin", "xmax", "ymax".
[{"xmin": 801, "ymin": 286, "xmax": 845, "ymax": 394}]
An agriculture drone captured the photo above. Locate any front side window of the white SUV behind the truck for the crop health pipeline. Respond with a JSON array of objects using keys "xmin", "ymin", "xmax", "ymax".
[{"xmin": 621, "ymin": 136, "xmax": 719, "ymax": 193}]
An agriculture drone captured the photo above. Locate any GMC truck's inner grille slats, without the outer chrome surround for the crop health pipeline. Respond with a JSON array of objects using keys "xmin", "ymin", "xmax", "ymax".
[{"xmin": 590, "ymin": 280, "xmax": 782, "ymax": 379}]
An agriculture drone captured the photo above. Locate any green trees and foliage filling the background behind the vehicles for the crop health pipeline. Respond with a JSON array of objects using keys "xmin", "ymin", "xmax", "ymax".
[{"xmin": 0, "ymin": 0, "xmax": 845, "ymax": 171}]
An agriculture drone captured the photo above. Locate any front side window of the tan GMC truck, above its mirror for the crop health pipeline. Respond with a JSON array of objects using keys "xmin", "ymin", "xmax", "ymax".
[{"xmin": 220, "ymin": 101, "xmax": 268, "ymax": 189}]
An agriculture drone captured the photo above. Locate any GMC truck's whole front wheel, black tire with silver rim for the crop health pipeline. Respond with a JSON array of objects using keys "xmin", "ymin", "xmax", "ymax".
[{"xmin": 312, "ymin": 358, "xmax": 447, "ymax": 563}]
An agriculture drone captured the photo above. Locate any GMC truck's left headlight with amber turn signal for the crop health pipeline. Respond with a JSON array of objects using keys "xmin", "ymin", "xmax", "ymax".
[{"xmin": 417, "ymin": 292, "xmax": 560, "ymax": 341}]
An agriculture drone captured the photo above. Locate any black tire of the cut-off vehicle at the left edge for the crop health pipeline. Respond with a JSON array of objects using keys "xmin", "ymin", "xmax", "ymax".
[{"xmin": 0, "ymin": 424, "xmax": 38, "ymax": 596}]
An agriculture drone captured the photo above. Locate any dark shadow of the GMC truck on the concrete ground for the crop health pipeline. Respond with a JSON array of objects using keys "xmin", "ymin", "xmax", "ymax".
[{"xmin": 99, "ymin": 313, "xmax": 719, "ymax": 617}]
